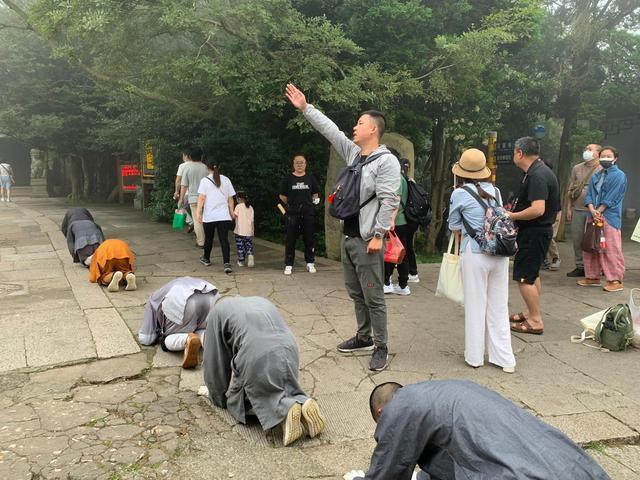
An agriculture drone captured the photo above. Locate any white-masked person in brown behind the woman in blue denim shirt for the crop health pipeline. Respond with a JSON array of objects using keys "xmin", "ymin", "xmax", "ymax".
[{"xmin": 564, "ymin": 143, "xmax": 601, "ymax": 277}]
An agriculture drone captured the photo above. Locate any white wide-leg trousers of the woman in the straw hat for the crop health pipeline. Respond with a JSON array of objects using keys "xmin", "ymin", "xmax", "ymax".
[{"xmin": 460, "ymin": 243, "xmax": 516, "ymax": 367}]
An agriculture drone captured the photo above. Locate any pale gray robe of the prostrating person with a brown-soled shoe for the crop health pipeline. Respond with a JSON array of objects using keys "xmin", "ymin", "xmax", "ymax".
[{"xmin": 138, "ymin": 277, "xmax": 218, "ymax": 345}]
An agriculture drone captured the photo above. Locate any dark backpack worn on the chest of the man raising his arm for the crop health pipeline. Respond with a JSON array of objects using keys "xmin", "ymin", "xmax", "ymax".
[{"xmin": 329, "ymin": 152, "xmax": 387, "ymax": 220}]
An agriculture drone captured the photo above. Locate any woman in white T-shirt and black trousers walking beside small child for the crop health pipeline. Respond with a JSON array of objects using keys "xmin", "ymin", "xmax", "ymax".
[{"xmin": 196, "ymin": 160, "xmax": 236, "ymax": 274}]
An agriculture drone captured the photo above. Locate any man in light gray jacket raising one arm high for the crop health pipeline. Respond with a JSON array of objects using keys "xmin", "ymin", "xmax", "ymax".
[{"xmin": 285, "ymin": 84, "xmax": 400, "ymax": 371}]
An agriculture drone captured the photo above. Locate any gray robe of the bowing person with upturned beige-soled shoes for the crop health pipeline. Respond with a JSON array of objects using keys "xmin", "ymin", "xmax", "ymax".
[{"xmin": 203, "ymin": 297, "xmax": 309, "ymax": 430}]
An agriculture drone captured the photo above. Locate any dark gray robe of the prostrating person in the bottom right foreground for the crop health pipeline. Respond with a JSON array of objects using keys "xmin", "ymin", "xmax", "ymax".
[{"xmin": 358, "ymin": 380, "xmax": 609, "ymax": 480}]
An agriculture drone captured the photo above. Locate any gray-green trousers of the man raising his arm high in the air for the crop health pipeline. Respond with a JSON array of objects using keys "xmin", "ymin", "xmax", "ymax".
[{"xmin": 342, "ymin": 236, "xmax": 387, "ymax": 346}]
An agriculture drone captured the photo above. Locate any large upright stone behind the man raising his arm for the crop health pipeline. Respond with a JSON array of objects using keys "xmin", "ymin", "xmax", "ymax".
[{"xmin": 324, "ymin": 133, "xmax": 415, "ymax": 260}]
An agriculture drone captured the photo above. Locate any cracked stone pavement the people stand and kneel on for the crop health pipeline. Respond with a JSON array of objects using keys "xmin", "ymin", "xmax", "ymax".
[{"xmin": 0, "ymin": 198, "xmax": 640, "ymax": 480}]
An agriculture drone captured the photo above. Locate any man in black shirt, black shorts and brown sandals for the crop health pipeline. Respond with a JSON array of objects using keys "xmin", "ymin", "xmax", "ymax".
[{"xmin": 509, "ymin": 137, "xmax": 560, "ymax": 335}]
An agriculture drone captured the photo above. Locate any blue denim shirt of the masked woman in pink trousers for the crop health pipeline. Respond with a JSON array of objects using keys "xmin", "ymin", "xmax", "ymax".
[{"xmin": 584, "ymin": 165, "xmax": 627, "ymax": 230}]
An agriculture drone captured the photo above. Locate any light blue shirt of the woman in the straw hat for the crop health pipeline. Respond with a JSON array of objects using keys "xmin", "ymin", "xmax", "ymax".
[{"xmin": 449, "ymin": 182, "xmax": 502, "ymax": 253}]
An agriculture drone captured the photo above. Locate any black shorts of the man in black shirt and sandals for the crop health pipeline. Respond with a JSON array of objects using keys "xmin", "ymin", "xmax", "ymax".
[{"xmin": 513, "ymin": 226, "xmax": 553, "ymax": 285}]
